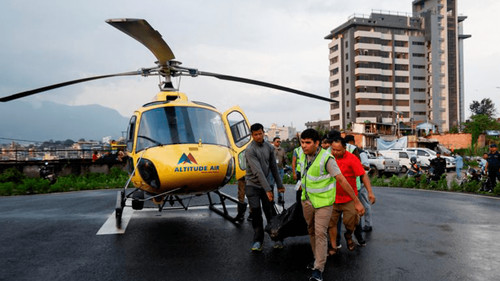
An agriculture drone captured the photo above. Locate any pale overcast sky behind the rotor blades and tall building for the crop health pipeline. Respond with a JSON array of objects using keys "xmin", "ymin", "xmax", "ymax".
[{"xmin": 0, "ymin": 0, "xmax": 500, "ymax": 130}]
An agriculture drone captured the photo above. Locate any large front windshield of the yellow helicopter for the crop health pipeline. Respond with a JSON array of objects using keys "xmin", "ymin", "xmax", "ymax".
[{"xmin": 136, "ymin": 106, "xmax": 229, "ymax": 151}]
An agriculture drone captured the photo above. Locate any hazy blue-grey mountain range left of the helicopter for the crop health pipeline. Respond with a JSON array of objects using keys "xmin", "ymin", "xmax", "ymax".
[{"xmin": 0, "ymin": 101, "xmax": 129, "ymax": 143}]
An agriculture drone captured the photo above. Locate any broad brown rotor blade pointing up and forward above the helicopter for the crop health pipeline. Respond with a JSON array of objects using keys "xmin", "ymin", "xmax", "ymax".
[{"xmin": 106, "ymin": 19, "xmax": 175, "ymax": 66}]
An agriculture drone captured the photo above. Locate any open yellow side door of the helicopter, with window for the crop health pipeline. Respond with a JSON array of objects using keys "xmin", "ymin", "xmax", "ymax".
[{"xmin": 222, "ymin": 106, "xmax": 251, "ymax": 179}]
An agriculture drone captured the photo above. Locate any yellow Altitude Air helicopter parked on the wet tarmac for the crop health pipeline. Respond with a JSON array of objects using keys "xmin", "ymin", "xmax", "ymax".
[{"xmin": 0, "ymin": 19, "xmax": 336, "ymax": 226}]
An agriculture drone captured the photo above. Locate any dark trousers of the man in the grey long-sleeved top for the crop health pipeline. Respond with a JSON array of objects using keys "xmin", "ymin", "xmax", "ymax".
[{"xmin": 245, "ymin": 185, "xmax": 272, "ymax": 243}]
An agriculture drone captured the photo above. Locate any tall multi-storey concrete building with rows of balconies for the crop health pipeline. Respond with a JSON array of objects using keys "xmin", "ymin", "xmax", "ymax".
[{"xmin": 325, "ymin": 0, "xmax": 468, "ymax": 132}]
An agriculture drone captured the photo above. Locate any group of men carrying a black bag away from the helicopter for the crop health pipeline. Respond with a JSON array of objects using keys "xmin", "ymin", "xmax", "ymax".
[{"xmin": 237, "ymin": 123, "xmax": 376, "ymax": 281}]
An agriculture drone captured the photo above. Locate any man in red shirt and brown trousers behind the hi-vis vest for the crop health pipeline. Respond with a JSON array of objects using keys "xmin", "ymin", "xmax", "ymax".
[{"xmin": 328, "ymin": 137, "xmax": 371, "ymax": 252}]
